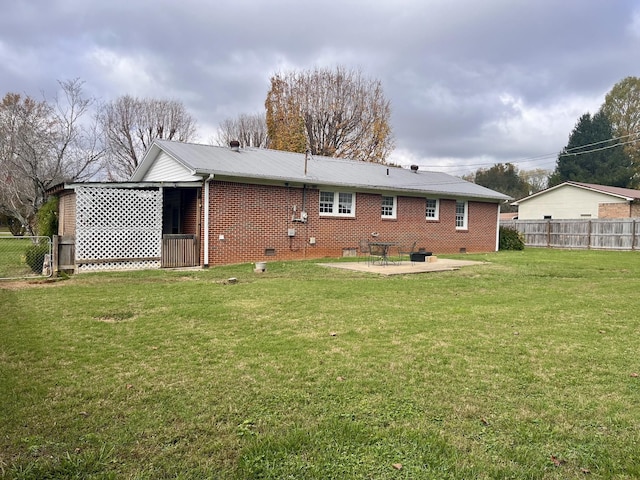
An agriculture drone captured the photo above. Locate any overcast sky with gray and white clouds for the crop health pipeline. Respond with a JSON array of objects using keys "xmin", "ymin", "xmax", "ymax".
[{"xmin": 0, "ymin": 0, "xmax": 640, "ymax": 175}]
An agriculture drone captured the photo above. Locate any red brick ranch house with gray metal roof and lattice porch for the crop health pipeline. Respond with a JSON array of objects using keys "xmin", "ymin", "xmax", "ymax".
[{"xmin": 51, "ymin": 140, "xmax": 510, "ymax": 271}]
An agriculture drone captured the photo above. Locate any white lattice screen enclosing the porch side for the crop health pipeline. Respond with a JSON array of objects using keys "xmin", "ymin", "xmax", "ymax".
[{"xmin": 76, "ymin": 187, "xmax": 162, "ymax": 271}]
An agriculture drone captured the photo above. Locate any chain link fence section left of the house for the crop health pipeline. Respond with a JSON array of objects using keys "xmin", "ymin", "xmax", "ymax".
[{"xmin": 0, "ymin": 235, "xmax": 53, "ymax": 280}]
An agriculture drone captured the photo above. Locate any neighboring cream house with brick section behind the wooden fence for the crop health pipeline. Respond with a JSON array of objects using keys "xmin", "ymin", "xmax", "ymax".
[{"xmin": 512, "ymin": 182, "xmax": 640, "ymax": 220}]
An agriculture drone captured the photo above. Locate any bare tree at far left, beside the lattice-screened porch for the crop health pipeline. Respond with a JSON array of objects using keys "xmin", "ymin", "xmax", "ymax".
[{"xmin": 0, "ymin": 79, "xmax": 102, "ymax": 234}]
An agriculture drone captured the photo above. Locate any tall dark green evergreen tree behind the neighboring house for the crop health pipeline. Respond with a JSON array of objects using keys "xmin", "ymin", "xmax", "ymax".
[{"xmin": 549, "ymin": 111, "xmax": 634, "ymax": 188}]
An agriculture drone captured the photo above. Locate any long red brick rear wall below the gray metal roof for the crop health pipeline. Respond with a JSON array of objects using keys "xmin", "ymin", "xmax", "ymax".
[{"xmin": 201, "ymin": 181, "xmax": 498, "ymax": 265}]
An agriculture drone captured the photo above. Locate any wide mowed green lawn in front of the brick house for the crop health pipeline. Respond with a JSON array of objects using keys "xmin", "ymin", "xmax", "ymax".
[{"xmin": 0, "ymin": 249, "xmax": 640, "ymax": 479}]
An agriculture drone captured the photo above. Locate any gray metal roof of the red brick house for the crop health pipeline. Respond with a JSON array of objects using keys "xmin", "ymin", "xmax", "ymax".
[{"xmin": 130, "ymin": 140, "xmax": 511, "ymax": 201}]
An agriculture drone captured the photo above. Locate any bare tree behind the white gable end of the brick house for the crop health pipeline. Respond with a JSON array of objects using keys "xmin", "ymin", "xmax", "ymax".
[{"xmin": 98, "ymin": 95, "xmax": 196, "ymax": 180}]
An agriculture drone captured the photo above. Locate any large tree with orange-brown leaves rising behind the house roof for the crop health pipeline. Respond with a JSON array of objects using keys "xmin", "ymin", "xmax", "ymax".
[{"xmin": 265, "ymin": 67, "xmax": 394, "ymax": 163}]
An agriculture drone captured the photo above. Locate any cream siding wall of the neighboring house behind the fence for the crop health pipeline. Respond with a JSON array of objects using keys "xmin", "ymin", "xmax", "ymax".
[{"xmin": 518, "ymin": 185, "xmax": 626, "ymax": 220}]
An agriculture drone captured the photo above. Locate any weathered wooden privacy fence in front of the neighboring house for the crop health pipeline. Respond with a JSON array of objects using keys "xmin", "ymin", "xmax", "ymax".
[{"xmin": 500, "ymin": 218, "xmax": 640, "ymax": 250}]
